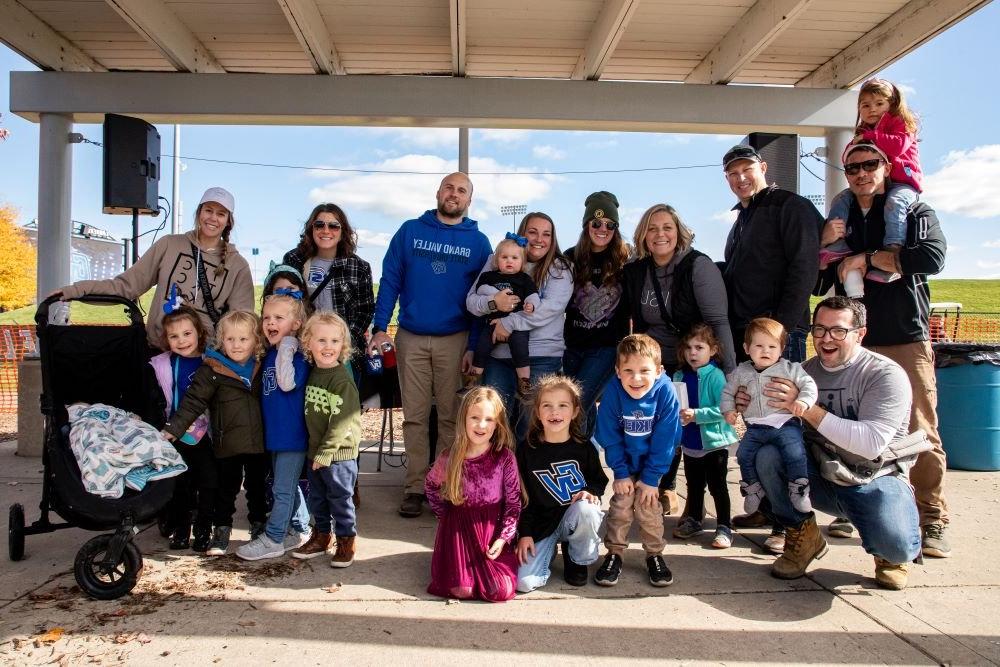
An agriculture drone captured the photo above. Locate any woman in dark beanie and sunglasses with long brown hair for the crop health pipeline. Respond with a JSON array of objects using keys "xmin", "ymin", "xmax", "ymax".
[{"xmin": 563, "ymin": 190, "xmax": 630, "ymax": 434}]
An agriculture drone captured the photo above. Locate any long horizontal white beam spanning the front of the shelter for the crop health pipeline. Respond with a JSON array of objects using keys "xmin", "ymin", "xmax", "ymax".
[{"xmin": 10, "ymin": 72, "xmax": 856, "ymax": 136}]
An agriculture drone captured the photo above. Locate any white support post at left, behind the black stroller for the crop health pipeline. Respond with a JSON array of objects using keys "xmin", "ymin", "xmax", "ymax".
[{"xmin": 38, "ymin": 113, "xmax": 73, "ymax": 300}]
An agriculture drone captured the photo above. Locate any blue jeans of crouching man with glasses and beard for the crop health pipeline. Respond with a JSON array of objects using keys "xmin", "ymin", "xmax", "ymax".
[{"xmin": 757, "ymin": 445, "xmax": 920, "ymax": 563}]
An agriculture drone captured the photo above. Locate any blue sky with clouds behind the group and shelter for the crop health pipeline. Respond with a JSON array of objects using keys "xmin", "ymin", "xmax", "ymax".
[{"xmin": 0, "ymin": 3, "xmax": 1000, "ymax": 280}]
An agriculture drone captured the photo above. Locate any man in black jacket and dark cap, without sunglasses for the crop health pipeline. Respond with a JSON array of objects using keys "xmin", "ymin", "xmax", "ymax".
[{"xmin": 722, "ymin": 145, "xmax": 823, "ymax": 361}]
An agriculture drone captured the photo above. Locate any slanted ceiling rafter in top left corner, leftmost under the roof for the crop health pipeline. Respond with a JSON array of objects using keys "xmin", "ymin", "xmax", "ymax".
[{"xmin": 0, "ymin": 0, "xmax": 107, "ymax": 72}]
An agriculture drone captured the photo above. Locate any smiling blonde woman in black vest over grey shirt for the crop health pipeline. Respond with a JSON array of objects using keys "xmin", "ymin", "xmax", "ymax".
[{"xmin": 622, "ymin": 204, "xmax": 736, "ymax": 516}]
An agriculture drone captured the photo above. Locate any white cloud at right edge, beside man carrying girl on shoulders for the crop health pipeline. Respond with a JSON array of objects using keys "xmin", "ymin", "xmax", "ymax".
[{"xmin": 921, "ymin": 144, "xmax": 1000, "ymax": 219}]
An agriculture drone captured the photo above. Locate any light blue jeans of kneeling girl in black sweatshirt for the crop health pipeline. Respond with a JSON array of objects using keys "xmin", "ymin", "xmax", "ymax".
[{"xmin": 517, "ymin": 500, "xmax": 604, "ymax": 593}]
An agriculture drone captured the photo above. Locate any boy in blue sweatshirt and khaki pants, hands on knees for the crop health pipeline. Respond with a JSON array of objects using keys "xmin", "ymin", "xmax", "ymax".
[{"xmin": 594, "ymin": 334, "xmax": 681, "ymax": 586}]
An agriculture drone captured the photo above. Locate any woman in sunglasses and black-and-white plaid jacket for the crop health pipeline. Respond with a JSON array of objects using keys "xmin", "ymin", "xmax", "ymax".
[{"xmin": 282, "ymin": 203, "xmax": 375, "ymax": 370}]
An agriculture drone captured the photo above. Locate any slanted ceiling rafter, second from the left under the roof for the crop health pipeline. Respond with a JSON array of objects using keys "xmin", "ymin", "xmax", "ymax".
[{"xmin": 106, "ymin": 0, "xmax": 226, "ymax": 74}]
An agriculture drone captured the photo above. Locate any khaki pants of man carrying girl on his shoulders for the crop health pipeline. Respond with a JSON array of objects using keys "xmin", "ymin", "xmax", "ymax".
[{"xmin": 870, "ymin": 341, "xmax": 948, "ymax": 526}]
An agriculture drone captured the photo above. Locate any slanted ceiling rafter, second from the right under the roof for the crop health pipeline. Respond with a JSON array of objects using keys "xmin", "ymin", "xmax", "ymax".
[{"xmin": 684, "ymin": 0, "xmax": 812, "ymax": 83}]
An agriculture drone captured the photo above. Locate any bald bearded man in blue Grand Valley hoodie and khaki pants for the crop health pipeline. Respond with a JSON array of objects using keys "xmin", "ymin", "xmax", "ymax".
[{"xmin": 370, "ymin": 172, "xmax": 492, "ymax": 517}]
